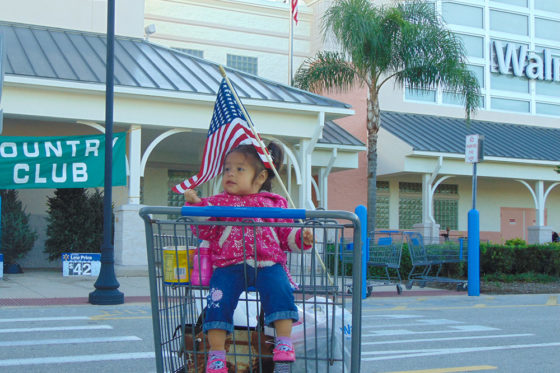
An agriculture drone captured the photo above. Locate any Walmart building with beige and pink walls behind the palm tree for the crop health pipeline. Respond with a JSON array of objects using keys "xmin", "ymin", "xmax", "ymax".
[{"xmin": 145, "ymin": 0, "xmax": 560, "ymax": 242}]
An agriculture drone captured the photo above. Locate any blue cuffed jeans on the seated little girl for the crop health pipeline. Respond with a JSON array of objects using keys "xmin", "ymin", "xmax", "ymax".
[{"xmin": 203, "ymin": 264, "xmax": 299, "ymax": 333}]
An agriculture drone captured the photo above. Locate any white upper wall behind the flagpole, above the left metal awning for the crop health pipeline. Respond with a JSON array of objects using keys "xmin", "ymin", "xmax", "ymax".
[{"xmin": 145, "ymin": 0, "xmax": 313, "ymax": 83}]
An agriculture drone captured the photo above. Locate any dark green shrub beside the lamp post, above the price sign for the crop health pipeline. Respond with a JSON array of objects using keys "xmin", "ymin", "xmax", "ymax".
[{"xmin": 45, "ymin": 188, "xmax": 109, "ymax": 261}]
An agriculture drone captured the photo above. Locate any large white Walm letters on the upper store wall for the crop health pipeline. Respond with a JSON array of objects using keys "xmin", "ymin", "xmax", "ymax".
[{"xmin": 492, "ymin": 40, "xmax": 560, "ymax": 82}]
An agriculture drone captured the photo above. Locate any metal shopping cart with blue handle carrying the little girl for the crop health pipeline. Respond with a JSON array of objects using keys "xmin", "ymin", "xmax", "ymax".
[{"xmin": 140, "ymin": 207, "xmax": 362, "ymax": 373}]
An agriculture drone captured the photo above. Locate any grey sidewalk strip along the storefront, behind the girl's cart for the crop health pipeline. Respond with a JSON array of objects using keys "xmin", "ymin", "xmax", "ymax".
[{"xmin": 0, "ymin": 267, "xmax": 466, "ymax": 307}]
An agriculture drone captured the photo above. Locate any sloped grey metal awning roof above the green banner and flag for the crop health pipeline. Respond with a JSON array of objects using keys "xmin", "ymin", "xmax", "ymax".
[{"xmin": 0, "ymin": 22, "xmax": 350, "ymax": 109}]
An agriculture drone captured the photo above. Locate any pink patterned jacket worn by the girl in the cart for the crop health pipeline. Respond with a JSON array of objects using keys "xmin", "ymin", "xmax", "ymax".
[{"xmin": 185, "ymin": 192, "xmax": 311, "ymax": 268}]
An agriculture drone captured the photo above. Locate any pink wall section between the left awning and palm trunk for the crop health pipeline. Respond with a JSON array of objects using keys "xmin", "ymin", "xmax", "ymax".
[{"xmin": 324, "ymin": 87, "xmax": 367, "ymax": 211}]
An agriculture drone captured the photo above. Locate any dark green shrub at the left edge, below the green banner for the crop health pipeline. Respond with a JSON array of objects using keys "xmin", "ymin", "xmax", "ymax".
[{"xmin": 0, "ymin": 190, "xmax": 37, "ymax": 264}]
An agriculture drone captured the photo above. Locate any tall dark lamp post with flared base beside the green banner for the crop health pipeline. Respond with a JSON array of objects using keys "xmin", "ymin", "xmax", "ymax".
[{"xmin": 89, "ymin": 0, "xmax": 124, "ymax": 304}]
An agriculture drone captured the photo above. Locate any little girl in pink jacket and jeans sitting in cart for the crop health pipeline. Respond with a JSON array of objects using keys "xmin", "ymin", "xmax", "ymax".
[{"xmin": 185, "ymin": 142, "xmax": 313, "ymax": 373}]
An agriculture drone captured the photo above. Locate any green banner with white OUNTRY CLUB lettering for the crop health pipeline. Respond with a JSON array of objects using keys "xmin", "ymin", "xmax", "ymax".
[{"xmin": 0, "ymin": 132, "xmax": 126, "ymax": 189}]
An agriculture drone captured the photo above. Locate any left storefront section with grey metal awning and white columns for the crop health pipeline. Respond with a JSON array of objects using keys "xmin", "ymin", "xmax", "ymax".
[{"xmin": 0, "ymin": 0, "xmax": 364, "ymax": 267}]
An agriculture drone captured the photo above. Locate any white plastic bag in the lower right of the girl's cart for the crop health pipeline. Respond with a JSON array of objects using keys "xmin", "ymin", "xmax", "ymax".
[{"xmin": 292, "ymin": 297, "xmax": 352, "ymax": 373}]
